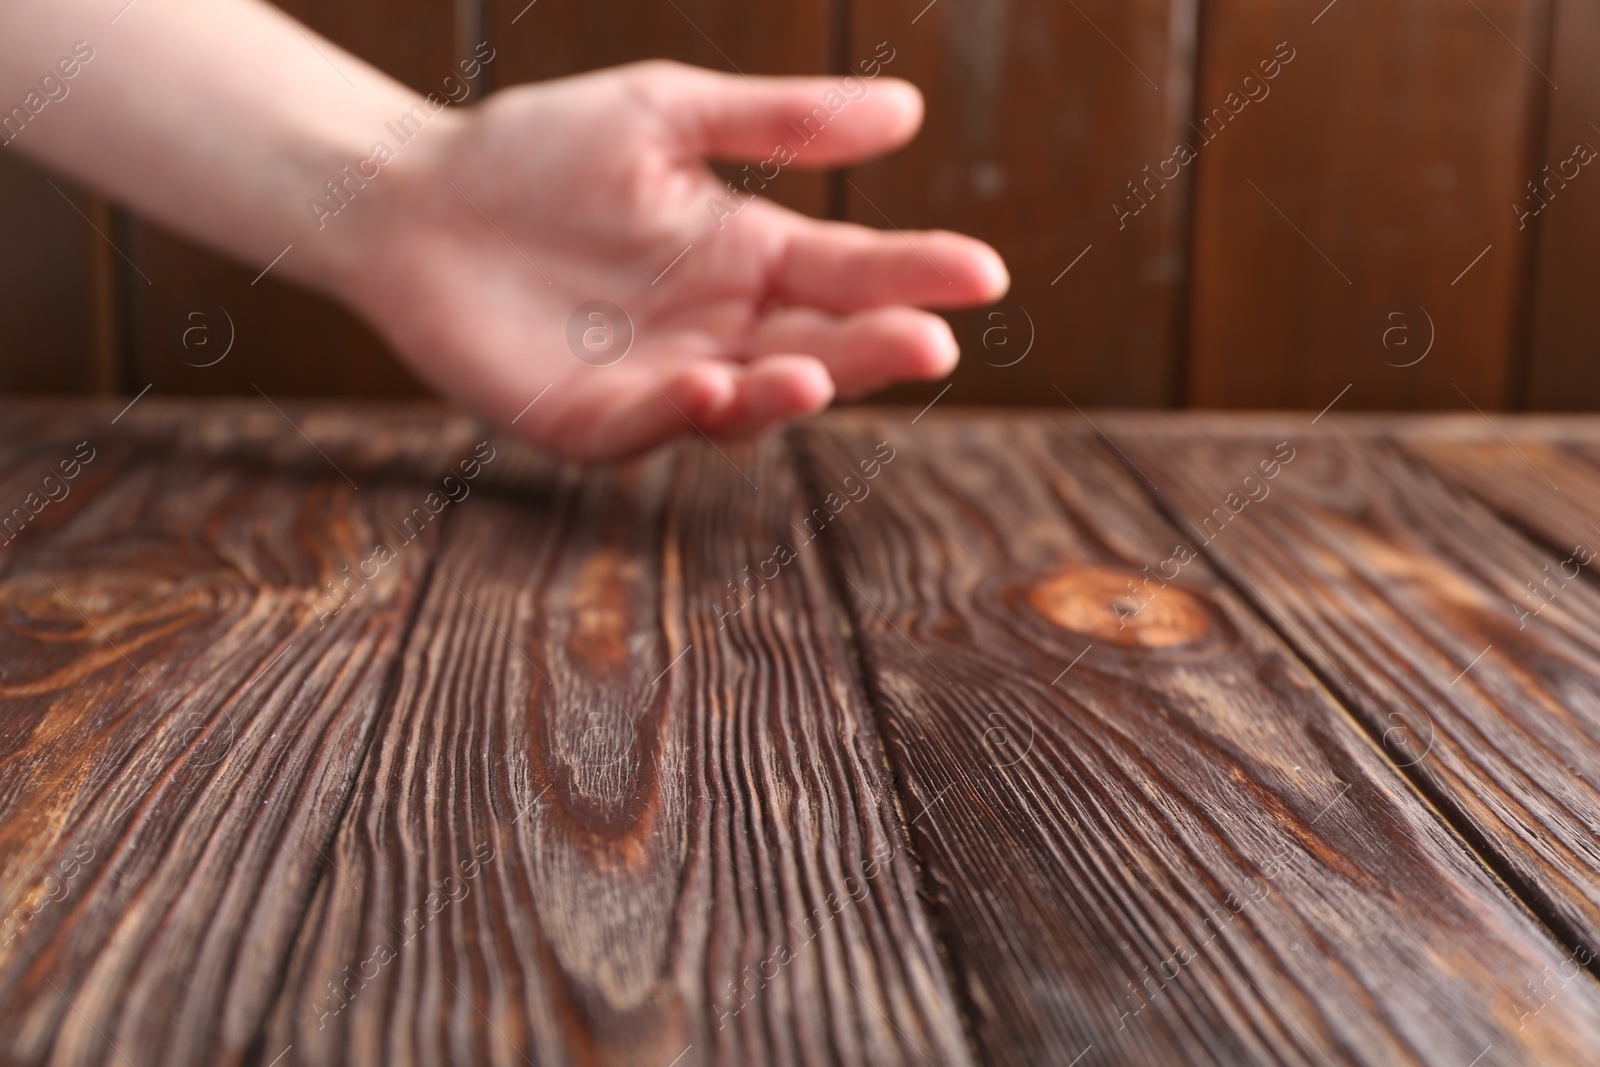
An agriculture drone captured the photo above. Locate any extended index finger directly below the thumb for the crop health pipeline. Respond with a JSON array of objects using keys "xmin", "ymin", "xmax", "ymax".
[{"xmin": 766, "ymin": 211, "xmax": 1011, "ymax": 312}]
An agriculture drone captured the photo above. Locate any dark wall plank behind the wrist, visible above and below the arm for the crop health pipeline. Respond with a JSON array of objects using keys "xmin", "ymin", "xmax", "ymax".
[{"xmin": 119, "ymin": 0, "xmax": 454, "ymax": 397}]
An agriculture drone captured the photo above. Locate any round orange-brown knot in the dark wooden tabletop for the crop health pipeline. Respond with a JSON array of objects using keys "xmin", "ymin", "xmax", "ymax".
[{"xmin": 1027, "ymin": 566, "xmax": 1211, "ymax": 648}]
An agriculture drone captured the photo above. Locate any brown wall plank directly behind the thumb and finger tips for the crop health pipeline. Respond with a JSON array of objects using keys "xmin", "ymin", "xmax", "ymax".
[{"xmin": 845, "ymin": 0, "xmax": 1198, "ymax": 406}]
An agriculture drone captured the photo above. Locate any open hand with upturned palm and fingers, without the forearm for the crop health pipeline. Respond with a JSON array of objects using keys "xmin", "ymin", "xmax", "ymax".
[{"xmin": 344, "ymin": 62, "xmax": 1008, "ymax": 459}]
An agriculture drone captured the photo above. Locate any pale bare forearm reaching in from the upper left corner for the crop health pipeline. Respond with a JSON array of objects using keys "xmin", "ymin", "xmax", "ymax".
[{"xmin": 0, "ymin": 0, "xmax": 448, "ymax": 288}]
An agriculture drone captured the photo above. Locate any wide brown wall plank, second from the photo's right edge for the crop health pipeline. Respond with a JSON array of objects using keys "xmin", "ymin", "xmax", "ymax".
[{"xmin": 1189, "ymin": 0, "xmax": 1549, "ymax": 411}]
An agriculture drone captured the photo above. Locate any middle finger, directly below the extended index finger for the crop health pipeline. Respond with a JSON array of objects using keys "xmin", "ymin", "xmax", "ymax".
[{"xmin": 750, "ymin": 307, "xmax": 960, "ymax": 400}]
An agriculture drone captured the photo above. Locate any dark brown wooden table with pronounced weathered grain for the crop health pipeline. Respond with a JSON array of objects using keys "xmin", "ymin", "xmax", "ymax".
[{"xmin": 9, "ymin": 398, "xmax": 1600, "ymax": 1067}]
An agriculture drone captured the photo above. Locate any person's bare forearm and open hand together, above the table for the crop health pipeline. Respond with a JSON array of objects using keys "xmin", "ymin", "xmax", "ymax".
[{"xmin": 0, "ymin": 0, "xmax": 1008, "ymax": 459}]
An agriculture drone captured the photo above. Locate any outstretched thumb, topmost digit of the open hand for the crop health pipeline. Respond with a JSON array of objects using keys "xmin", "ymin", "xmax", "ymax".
[{"xmin": 634, "ymin": 62, "xmax": 923, "ymax": 173}]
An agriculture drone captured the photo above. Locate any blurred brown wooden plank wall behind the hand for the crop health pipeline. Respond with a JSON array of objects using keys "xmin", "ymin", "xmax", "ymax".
[{"xmin": 0, "ymin": 0, "xmax": 1600, "ymax": 410}]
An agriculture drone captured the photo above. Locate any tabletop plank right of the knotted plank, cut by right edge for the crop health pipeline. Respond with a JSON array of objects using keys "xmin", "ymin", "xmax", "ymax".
[{"xmin": 1109, "ymin": 415, "xmax": 1600, "ymax": 945}]
